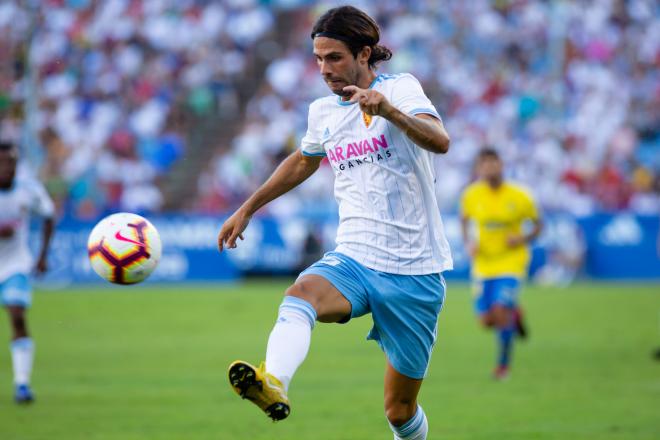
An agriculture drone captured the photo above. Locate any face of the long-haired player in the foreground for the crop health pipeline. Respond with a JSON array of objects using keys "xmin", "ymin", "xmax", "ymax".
[{"xmin": 314, "ymin": 37, "xmax": 368, "ymax": 96}]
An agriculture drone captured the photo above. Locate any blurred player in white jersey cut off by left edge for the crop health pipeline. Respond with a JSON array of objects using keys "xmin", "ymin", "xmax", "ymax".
[{"xmin": 0, "ymin": 142, "xmax": 55, "ymax": 403}]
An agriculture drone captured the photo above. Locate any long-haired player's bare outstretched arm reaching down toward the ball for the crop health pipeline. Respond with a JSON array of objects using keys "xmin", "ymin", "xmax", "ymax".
[{"xmin": 218, "ymin": 150, "xmax": 323, "ymax": 252}]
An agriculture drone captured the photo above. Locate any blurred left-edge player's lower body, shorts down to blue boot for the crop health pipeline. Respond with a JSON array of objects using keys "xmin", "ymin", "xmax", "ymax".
[{"xmin": 0, "ymin": 274, "xmax": 34, "ymax": 403}]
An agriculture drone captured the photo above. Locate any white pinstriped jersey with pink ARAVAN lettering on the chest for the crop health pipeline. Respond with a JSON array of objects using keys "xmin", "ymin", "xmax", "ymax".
[{"xmin": 301, "ymin": 73, "xmax": 453, "ymax": 275}]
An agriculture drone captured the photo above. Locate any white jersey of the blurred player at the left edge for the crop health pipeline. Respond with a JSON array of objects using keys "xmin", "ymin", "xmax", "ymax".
[{"xmin": 0, "ymin": 178, "xmax": 55, "ymax": 283}]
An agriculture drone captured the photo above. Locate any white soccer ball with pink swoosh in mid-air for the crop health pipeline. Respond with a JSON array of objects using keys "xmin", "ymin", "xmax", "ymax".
[{"xmin": 87, "ymin": 212, "xmax": 162, "ymax": 284}]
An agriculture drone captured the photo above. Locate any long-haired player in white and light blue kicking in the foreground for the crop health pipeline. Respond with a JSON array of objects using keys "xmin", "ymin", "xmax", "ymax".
[{"xmin": 218, "ymin": 6, "xmax": 452, "ymax": 439}]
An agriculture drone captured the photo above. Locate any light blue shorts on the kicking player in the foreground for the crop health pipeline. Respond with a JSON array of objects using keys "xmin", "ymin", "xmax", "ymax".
[{"xmin": 300, "ymin": 252, "xmax": 446, "ymax": 379}]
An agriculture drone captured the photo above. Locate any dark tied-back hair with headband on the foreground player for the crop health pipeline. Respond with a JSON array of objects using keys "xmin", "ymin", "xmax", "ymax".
[{"xmin": 312, "ymin": 6, "xmax": 392, "ymax": 69}]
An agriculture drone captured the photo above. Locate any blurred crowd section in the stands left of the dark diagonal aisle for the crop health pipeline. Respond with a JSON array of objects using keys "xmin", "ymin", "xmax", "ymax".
[{"xmin": 0, "ymin": 0, "xmax": 273, "ymax": 218}]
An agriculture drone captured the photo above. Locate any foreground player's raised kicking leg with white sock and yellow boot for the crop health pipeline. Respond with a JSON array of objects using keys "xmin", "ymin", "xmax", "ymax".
[{"xmin": 229, "ymin": 254, "xmax": 360, "ymax": 420}]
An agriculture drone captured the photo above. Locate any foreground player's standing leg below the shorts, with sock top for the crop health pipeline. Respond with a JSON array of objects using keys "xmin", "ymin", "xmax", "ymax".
[{"xmin": 385, "ymin": 362, "xmax": 429, "ymax": 440}]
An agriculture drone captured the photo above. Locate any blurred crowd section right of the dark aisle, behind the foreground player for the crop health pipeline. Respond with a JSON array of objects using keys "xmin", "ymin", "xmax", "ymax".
[{"xmin": 199, "ymin": 0, "xmax": 660, "ymax": 215}]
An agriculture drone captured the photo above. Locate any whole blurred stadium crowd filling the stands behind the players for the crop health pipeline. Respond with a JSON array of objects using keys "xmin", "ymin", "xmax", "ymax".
[{"xmin": 0, "ymin": 0, "xmax": 660, "ymax": 217}]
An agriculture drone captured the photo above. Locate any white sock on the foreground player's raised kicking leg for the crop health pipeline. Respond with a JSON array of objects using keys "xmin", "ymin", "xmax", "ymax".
[{"xmin": 266, "ymin": 296, "xmax": 316, "ymax": 390}]
